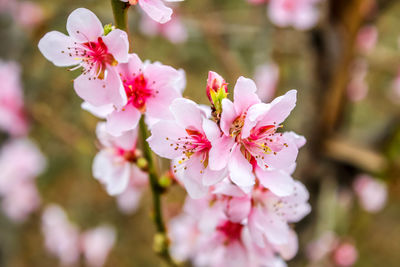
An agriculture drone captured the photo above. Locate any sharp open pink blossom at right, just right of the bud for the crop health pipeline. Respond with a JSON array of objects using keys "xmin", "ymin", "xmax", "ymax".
[{"xmin": 210, "ymin": 77, "xmax": 298, "ymax": 195}]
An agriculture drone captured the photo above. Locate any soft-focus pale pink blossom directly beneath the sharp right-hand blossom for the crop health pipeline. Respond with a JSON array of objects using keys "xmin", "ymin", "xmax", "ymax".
[{"xmin": 213, "ymin": 180, "xmax": 311, "ymax": 248}]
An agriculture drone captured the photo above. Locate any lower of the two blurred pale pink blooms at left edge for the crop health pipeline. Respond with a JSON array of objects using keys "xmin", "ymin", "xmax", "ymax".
[{"xmin": 0, "ymin": 139, "xmax": 45, "ymax": 222}]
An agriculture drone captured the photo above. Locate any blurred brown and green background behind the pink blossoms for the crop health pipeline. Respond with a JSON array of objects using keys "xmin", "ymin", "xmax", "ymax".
[{"xmin": 0, "ymin": 0, "xmax": 400, "ymax": 267}]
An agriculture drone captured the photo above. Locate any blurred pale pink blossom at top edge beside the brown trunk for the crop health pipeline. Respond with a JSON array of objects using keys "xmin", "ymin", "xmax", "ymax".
[{"xmin": 268, "ymin": 0, "xmax": 320, "ymax": 30}]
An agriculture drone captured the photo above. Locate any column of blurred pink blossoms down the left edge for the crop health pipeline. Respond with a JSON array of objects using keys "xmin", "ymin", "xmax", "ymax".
[{"xmin": 0, "ymin": 61, "xmax": 46, "ymax": 222}]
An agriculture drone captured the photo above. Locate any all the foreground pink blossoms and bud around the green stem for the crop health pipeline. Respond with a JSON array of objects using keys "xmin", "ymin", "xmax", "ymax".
[{"xmin": 39, "ymin": 6, "xmax": 310, "ymax": 266}]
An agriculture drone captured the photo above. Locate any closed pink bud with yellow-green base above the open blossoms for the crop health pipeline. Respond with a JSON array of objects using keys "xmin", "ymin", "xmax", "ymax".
[{"xmin": 207, "ymin": 71, "xmax": 228, "ymax": 114}]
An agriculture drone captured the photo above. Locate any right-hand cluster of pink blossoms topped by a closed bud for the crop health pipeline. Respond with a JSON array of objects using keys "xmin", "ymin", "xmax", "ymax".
[{"xmin": 152, "ymin": 72, "xmax": 310, "ymax": 266}]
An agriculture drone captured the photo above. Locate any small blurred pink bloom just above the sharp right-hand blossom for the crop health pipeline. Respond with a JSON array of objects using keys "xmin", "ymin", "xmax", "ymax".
[{"xmin": 254, "ymin": 63, "xmax": 279, "ymax": 102}]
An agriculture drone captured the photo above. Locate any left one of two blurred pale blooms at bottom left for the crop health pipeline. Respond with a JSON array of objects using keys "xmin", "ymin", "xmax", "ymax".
[{"xmin": 42, "ymin": 205, "xmax": 80, "ymax": 265}]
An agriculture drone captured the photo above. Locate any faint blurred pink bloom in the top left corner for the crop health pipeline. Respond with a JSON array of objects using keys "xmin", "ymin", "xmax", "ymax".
[{"xmin": 14, "ymin": 1, "xmax": 44, "ymax": 29}]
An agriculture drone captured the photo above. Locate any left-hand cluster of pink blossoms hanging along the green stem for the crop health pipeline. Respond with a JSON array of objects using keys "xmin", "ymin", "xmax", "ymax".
[{"xmin": 39, "ymin": 7, "xmax": 186, "ymax": 212}]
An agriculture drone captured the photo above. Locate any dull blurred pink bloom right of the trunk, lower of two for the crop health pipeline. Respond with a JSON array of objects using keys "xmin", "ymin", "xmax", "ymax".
[{"xmin": 347, "ymin": 59, "xmax": 368, "ymax": 102}]
